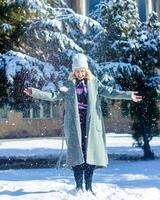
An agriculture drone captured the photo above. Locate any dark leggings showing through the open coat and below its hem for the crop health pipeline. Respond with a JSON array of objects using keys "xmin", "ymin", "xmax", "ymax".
[{"xmin": 73, "ymin": 109, "xmax": 95, "ymax": 190}]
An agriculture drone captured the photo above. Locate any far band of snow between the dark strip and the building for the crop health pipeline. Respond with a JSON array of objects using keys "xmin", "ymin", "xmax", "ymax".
[{"xmin": 0, "ymin": 133, "xmax": 160, "ymax": 157}]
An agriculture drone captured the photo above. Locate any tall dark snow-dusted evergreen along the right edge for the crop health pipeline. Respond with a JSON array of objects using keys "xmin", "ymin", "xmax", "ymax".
[{"xmin": 114, "ymin": 13, "xmax": 160, "ymax": 155}]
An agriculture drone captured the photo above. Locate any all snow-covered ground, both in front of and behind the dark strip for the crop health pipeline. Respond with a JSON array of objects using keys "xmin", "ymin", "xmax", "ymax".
[{"xmin": 0, "ymin": 134, "xmax": 160, "ymax": 200}]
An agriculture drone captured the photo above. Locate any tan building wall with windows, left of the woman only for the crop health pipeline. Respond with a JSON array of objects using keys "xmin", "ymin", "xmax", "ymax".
[{"xmin": 0, "ymin": 101, "xmax": 63, "ymax": 139}]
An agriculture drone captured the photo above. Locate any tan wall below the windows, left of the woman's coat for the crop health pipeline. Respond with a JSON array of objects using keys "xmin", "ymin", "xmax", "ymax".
[{"xmin": 0, "ymin": 111, "xmax": 62, "ymax": 139}]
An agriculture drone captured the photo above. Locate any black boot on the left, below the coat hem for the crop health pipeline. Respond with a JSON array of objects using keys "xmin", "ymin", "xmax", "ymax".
[{"xmin": 72, "ymin": 165, "xmax": 83, "ymax": 191}]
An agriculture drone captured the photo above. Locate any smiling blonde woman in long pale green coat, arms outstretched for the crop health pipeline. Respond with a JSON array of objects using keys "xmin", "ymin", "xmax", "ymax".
[{"xmin": 24, "ymin": 53, "xmax": 142, "ymax": 194}]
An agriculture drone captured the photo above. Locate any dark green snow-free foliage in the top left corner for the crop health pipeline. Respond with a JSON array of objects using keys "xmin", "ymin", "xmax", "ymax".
[{"xmin": 0, "ymin": 0, "xmax": 33, "ymax": 53}]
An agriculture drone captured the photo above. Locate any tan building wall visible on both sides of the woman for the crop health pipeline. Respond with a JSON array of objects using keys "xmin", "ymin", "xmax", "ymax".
[{"xmin": 0, "ymin": 103, "xmax": 136, "ymax": 139}]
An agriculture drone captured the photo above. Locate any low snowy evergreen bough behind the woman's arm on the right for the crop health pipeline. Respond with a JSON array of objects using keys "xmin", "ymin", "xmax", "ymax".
[{"xmin": 97, "ymin": 62, "xmax": 145, "ymax": 117}]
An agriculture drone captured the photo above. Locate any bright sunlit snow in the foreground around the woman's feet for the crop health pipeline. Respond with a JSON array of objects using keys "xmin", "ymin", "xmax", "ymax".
[{"xmin": 0, "ymin": 180, "xmax": 160, "ymax": 200}]
